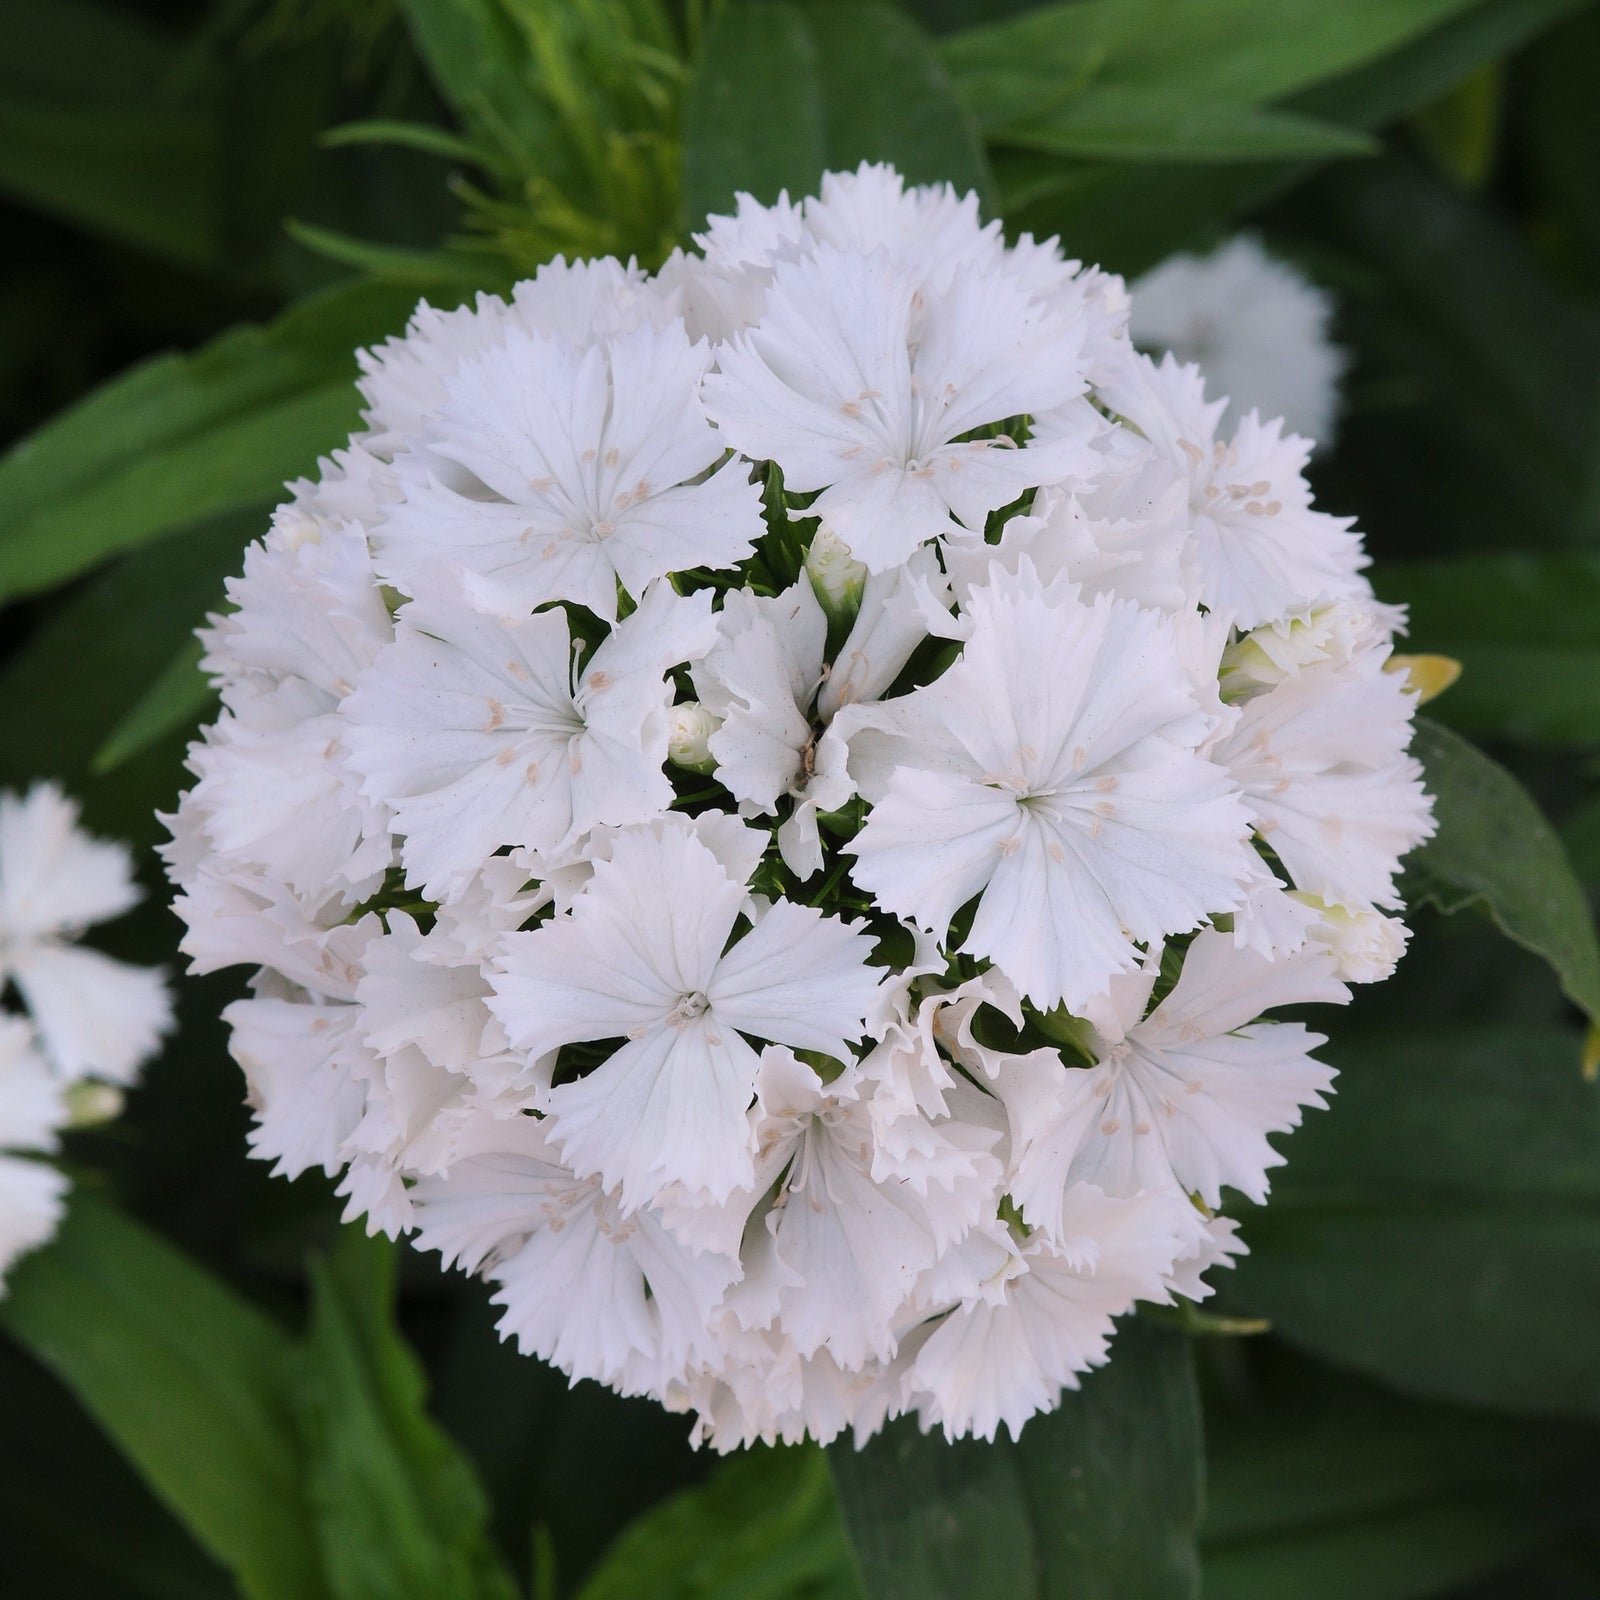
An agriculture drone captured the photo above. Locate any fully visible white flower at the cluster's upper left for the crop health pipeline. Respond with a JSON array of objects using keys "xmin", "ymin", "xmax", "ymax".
[{"xmin": 378, "ymin": 325, "xmax": 762, "ymax": 621}]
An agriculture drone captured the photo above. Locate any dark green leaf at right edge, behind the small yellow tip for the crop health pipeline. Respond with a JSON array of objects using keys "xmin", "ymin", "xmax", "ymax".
[{"xmin": 1376, "ymin": 555, "xmax": 1600, "ymax": 746}]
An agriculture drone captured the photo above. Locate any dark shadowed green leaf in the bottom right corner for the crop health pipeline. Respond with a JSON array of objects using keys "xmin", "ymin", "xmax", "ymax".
[{"xmin": 1200, "ymin": 1360, "xmax": 1595, "ymax": 1600}]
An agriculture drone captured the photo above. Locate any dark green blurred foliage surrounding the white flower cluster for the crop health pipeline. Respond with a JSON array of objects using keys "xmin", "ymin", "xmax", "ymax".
[{"xmin": 0, "ymin": 0, "xmax": 1600, "ymax": 1600}]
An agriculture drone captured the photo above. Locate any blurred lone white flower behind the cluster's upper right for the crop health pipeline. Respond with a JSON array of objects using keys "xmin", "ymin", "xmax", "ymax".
[{"xmin": 1128, "ymin": 234, "xmax": 1347, "ymax": 446}]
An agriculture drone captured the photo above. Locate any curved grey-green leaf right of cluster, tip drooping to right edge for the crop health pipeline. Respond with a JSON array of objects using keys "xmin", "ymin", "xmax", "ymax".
[{"xmin": 1402, "ymin": 717, "xmax": 1600, "ymax": 1021}]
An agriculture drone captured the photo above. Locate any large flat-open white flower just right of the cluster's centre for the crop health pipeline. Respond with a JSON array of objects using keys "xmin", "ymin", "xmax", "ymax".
[{"xmin": 843, "ymin": 568, "xmax": 1254, "ymax": 1006}]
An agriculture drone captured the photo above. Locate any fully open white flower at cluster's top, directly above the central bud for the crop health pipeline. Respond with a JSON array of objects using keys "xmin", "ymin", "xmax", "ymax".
[{"xmin": 706, "ymin": 246, "xmax": 1083, "ymax": 573}]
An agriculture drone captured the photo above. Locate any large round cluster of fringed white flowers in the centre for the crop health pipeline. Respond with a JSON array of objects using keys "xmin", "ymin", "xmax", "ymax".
[{"xmin": 170, "ymin": 166, "xmax": 1432, "ymax": 1450}]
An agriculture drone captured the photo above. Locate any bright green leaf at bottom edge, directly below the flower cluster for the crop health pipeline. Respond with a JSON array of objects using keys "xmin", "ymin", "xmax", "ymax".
[{"xmin": 578, "ymin": 1446, "xmax": 861, "ymax": 1600}]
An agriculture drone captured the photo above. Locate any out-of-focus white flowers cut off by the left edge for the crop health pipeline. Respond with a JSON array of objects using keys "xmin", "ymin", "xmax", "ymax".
[{"xmin": 0, "ymin": 784, "xmax": 171, "ymax": 1293}]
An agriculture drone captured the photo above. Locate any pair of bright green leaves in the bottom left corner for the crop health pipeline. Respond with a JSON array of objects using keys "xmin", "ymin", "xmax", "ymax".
[{"xmin": 0, "ymin": 1192, "xmax": 518, "ymax": 1600}]
